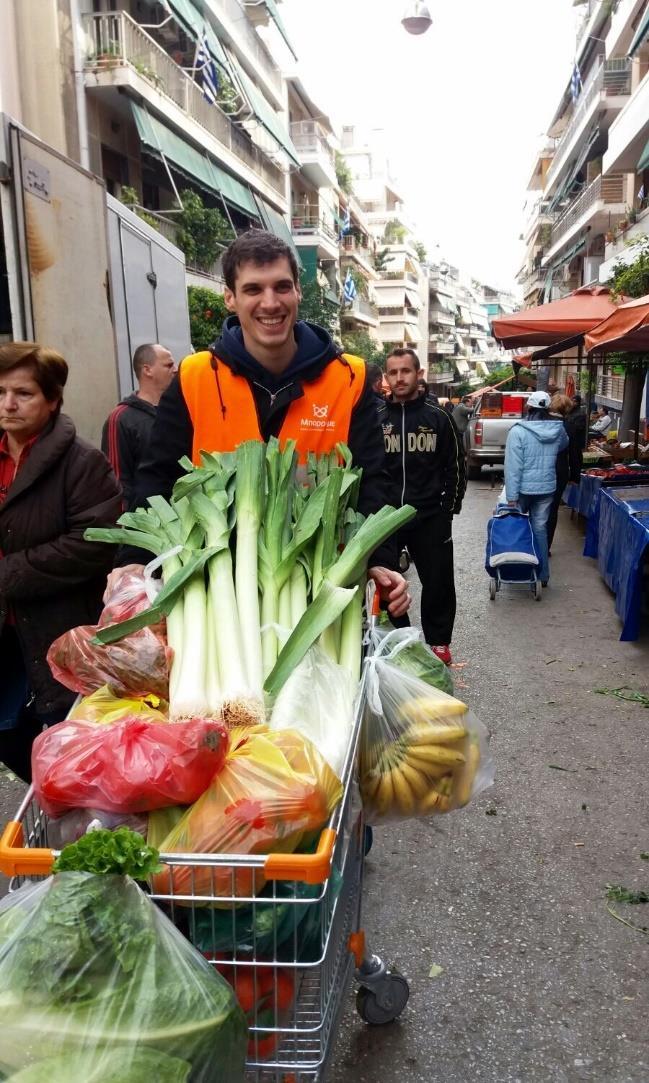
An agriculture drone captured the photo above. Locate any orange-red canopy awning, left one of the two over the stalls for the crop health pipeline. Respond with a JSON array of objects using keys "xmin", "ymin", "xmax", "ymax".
[{"xmin": 492, "ymin": 286, "xmax": 616, "ymax": 350}]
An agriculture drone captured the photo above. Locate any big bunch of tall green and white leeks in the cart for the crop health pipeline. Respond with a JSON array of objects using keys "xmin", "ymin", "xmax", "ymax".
[{"xmin": 85, "ymin": 439, "xmax": 415, "ymax": 726}]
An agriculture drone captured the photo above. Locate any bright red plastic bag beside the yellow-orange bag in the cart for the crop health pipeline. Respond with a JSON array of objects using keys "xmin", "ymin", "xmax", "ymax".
[{"xmin": 31, "ymin": 718, "xmax": 229, "ymax": 817}]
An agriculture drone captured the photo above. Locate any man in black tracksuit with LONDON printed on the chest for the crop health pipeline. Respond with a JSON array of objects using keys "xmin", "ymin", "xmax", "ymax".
[{"xmin": 379, "ymin": 349, "xmax": 466, "ymax": 664}]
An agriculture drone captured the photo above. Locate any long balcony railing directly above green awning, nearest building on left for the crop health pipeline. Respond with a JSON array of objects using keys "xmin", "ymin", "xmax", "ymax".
[{"xmin": 83, "ymin": 12, "xmax": 285, "ymax": 195}]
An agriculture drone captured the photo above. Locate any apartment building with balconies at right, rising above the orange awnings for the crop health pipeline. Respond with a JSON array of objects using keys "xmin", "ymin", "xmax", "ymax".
[{"xmin": 518, "ymin": 0, "xmax": 649, "ymax": 410}]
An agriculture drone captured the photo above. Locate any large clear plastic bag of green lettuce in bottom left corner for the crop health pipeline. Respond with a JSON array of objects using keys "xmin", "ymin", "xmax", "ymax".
[{"xmin": 0, "ymin": 828, "xmax": 247, "ymax": 1083}]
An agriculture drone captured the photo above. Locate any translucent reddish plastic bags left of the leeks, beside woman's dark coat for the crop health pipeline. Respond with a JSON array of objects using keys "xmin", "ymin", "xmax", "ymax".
[{"xmin": 48, "ymin": 564, "xmax": 172, "ymax": 699}]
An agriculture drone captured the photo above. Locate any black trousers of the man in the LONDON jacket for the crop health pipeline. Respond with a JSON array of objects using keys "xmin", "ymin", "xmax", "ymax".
[{"xmin": 393, "ymin": 516, "xmax": 456, "ymax": 647}]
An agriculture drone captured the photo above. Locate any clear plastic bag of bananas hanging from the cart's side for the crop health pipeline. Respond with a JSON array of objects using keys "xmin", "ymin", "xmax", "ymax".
[{"xmin": 359, "ymin": 628, "xmax": 494, "ymax": 824}]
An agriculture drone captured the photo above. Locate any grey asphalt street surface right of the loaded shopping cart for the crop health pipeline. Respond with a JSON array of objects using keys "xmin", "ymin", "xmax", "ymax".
[{"xmin": 0, "ymin": 474, "xmax": 649, "ymax": 1083}]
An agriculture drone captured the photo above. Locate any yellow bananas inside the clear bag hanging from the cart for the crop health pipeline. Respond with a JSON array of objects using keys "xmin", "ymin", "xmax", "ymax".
[{"xmin": 360, "ymin": 694, "xmax": 480, "ymax": 819}]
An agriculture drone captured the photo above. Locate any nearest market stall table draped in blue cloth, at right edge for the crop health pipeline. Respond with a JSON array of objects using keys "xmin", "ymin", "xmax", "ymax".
[{"xmin": 584, "ymin": 485, "xmax": 649, "ymax": 640}]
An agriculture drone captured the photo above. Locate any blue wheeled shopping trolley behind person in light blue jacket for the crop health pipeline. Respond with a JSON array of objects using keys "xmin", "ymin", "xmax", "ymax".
[{"xmin": 484, "ymin": 504, "xmax": 543, "ymax": 602}]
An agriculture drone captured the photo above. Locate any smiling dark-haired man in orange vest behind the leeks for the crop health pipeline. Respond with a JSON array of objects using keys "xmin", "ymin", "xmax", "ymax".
[{"xmin": 134, "ymin": 230, "xmax": 410, "ymax": 617}]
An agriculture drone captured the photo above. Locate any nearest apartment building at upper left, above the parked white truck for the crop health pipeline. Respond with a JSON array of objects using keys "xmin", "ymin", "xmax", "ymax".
[{"xmin": 2, "ymin": 0, "xmax": 301, "ymax": 288}]
